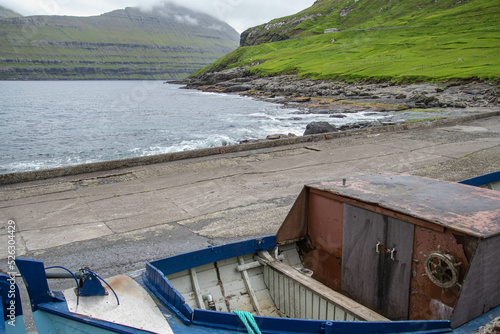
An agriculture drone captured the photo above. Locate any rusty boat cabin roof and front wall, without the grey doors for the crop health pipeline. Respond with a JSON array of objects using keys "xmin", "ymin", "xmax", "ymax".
[{"xmin": 282, "ymin": 173, "xmax": 500, "ymax": 320}]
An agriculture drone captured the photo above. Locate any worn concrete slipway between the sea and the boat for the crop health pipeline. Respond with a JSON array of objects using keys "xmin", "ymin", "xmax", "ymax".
[{"xmin": 0, "ymin": 108, "xmax": 500, "ymax": 296}]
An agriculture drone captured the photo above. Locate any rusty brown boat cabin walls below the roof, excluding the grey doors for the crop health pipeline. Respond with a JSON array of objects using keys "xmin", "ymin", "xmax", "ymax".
[{"xmin": 277, "ymin": 183, "xmax": 500, "ymax": 324}]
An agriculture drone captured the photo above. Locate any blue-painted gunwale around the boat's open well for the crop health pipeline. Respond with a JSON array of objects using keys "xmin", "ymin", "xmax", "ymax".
[{"xmin": 143, "ymin": 236, "xmax": 451, "ymax": 333}]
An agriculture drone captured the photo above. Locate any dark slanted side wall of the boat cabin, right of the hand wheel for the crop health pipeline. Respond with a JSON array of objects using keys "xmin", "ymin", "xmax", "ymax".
[{"xmin": 451, "ymin": 235, "xmax": 500, "ymax": 328}]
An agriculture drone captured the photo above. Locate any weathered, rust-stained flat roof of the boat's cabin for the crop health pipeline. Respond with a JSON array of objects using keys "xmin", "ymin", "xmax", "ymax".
[{"xmin": 309, "ymin": 173, "xmax": 500, "ymax": 238}]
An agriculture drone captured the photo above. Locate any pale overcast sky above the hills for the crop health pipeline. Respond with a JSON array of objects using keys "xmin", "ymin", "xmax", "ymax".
[{"xmin": 0, "ymin": 0, "xmax": 315, "ymax": 33}]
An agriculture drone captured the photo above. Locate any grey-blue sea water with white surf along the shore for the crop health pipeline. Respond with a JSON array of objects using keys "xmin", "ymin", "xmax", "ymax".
[{"xmin": 0, "ymin": 81, "xmax": 377, "ymax": 174}]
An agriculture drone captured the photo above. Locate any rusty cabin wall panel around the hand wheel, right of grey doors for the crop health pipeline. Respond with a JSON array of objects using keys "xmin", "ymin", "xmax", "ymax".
[{"xmin": 409, "ymin": 226, "xmax": 477, "ymax": 320}]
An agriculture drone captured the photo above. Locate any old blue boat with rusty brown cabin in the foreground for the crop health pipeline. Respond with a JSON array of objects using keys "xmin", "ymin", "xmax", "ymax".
[{"xmin": 7, "ymin": 173, "xmax": 500, "ymax": 333}]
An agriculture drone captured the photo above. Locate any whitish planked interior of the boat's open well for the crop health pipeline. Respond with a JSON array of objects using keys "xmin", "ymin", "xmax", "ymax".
[{"xmin": 167, "ymin": 243, "xmax": 389, "ymax": 321}]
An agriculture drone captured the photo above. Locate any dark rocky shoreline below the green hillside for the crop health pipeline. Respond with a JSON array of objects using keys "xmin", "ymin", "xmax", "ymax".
[{"xmin": 176, "ymin": 67, "xmax": 500, "ymax": 138}]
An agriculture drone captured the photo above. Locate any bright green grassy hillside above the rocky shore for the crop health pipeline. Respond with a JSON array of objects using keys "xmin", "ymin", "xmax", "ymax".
[{"xmin": 194, "ymin": 0, "xmax": 500, "ymax": 81}]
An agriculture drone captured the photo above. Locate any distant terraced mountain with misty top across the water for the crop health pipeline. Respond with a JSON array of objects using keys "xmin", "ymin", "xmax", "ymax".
[{"xmin": 0, "ymin": 4, "xmax": 239, "ymax": 80}]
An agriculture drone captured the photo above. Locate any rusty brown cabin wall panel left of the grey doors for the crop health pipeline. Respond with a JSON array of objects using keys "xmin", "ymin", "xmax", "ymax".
[{"xmin": 303, "ymin": 189, "xmax": 343, "ymax": 291}]
